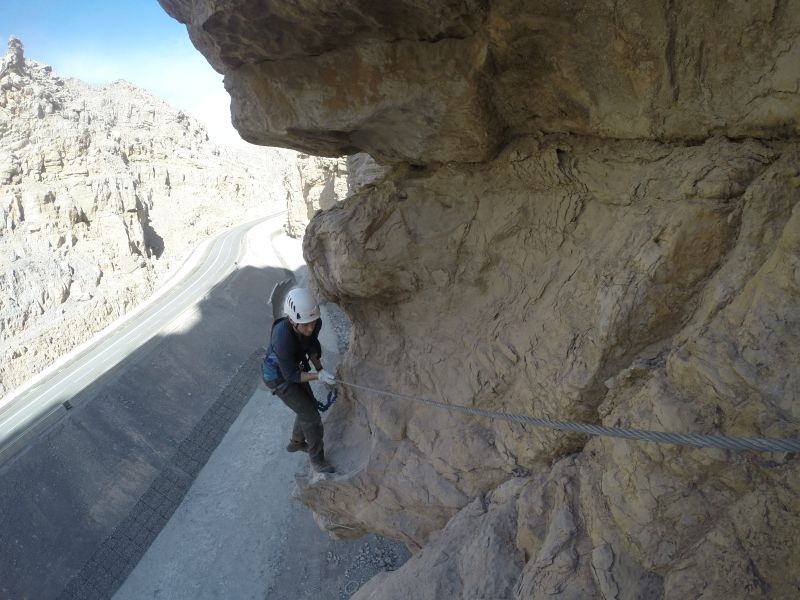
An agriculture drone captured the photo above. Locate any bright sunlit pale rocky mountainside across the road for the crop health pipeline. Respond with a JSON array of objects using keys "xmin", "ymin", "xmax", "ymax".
[{"xmin": 0, "ymin": 38, "xmax": 291, "ymax": 396}]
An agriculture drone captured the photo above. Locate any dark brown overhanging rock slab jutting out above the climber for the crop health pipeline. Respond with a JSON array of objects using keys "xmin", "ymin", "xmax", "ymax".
[{"xmin": 161, "ymin": 0, "xmax": 800, "ymax": 164}]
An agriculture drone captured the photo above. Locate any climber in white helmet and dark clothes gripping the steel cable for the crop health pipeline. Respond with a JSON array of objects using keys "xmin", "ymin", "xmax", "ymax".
[{"xmin": 261, "ymin": 288, "xmax": 335, "ymax": 473}]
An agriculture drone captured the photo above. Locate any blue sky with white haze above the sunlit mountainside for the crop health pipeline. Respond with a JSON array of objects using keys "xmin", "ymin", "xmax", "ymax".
[{"xmin": 0, "ymin": 0, "xmax": 238, "ymax": 141}]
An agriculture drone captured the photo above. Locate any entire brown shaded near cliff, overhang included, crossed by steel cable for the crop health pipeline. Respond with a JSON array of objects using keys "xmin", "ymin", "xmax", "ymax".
[{"xmin": 160, "ymin": 0, "xmax": 800, "ymax": 599}]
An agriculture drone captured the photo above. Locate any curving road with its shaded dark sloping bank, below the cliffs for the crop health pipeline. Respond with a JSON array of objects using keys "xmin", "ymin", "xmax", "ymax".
[{"xmin": 0, "ymin": 210, "xmax": 302, "ymax": 600}]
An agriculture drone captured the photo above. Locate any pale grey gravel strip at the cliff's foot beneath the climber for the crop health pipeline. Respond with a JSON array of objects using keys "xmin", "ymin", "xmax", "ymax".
[{"xmin": 111, "ymin": 306, "xmax": 408, "ymax": 600}]
